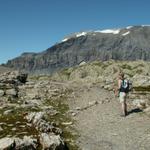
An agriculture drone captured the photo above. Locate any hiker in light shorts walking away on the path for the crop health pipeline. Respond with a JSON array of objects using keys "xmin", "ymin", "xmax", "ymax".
[{"xmin": 115, "ymin": 72, "xmax": 129, "ymax": 117}]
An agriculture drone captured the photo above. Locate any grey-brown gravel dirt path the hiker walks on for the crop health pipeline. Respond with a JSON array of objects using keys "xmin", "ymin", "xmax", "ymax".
[{"xmin": 70, "ymin": 86, "xmax": 150, "ymax": 150}]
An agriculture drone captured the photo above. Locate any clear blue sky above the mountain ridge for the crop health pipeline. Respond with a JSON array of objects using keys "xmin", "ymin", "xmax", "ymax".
[{"xmin": 0, "ymin": 0, "xmax": 150, "ymax": 63}]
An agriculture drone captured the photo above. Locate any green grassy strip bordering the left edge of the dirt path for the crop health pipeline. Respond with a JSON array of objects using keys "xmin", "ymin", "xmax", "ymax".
[{"xmin": 45, "ymin": 93, "xmax": 78, "ymax": 150}]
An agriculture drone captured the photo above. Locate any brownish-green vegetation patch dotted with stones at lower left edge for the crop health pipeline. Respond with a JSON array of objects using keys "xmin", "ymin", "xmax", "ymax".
[{"xmin": 0, "ymin": 110, "xmax": 38, "ymax": 138}]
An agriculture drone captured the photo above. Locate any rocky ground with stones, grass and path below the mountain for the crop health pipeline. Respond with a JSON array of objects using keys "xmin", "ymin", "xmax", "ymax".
[{"xmin": 0, "ymin": 61, "xmax": 150, "ymax": 150}]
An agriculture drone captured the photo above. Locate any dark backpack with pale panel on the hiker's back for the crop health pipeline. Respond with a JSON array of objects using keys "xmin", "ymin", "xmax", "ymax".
[{"xmin": 120, "ymin": 79, "xmax": 132, "ymax": 93}]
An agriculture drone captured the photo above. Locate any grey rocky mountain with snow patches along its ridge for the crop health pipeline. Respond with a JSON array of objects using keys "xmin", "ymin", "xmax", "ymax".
[{"xmin": 5, "ymin": 25, "xmax": 150, "ymax": 72}]
